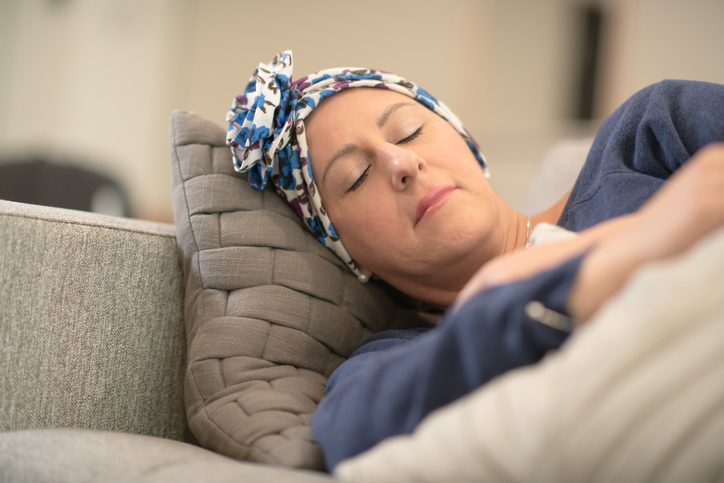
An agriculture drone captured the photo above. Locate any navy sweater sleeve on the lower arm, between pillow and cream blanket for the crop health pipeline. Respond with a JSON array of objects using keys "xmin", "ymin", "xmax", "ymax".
[{"xmin": 312, "ymin": 256, "xmax": 583, "ymax": 470}]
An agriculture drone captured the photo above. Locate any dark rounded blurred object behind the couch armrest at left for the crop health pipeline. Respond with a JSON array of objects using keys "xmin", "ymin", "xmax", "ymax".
[{"xmin": 0, "ymin": 159, "xmax": 130, "ymax": 216}]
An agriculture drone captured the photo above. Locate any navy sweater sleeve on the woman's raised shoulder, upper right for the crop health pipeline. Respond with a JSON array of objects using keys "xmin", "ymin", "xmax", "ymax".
[{"xmin": 558, "ymin": 80, "xmax": 724, "ymax": 231}]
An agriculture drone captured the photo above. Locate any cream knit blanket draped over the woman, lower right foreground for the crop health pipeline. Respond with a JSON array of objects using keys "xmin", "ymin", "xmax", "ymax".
[{"xmin": 335, "ymin": 230, "xmax": 724, "ymax": 483}]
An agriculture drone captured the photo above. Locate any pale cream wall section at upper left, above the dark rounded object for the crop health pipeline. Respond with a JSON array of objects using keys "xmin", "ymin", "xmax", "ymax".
[{"xmin": 0, "ymin": 0, "xmax": 191, "ymax": 219}]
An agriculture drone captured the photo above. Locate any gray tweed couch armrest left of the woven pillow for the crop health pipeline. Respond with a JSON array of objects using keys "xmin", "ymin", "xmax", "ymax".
[{"xmin": 0, "ymin": 201, "xmax": 193, "ymax": 441}]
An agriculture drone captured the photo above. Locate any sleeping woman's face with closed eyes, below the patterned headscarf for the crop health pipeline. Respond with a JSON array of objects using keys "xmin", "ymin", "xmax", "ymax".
[{"xmin": 305, "ymin": 88, "xmax": 502, "ymax": 305}]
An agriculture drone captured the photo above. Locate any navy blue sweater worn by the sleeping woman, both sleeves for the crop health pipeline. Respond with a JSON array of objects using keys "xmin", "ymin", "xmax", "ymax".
[{"xmin": 312, "ymin": 81, "xmax": 724, "ymax": 470}]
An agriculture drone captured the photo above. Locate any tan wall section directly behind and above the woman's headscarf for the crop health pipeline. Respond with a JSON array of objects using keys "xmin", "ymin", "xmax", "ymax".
[{"xmin": 184, "ymin": 0, "xmax": 491, "ymax": 138}]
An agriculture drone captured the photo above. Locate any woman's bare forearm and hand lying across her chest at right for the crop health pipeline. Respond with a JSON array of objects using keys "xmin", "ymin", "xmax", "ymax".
[{"xmin": 455, "ymin": 143, "xmax": 724, "ymax": 322}]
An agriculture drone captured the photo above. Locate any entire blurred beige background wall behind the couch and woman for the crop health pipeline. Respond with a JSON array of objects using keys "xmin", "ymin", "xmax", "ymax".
[{"xmin": 0, "ymin": 0, "xmax": 724, "ymax": 222}]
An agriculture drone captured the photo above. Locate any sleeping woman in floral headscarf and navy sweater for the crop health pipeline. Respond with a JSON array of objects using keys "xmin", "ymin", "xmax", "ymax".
[{"xmin": 227, "ymin": 51, "xmax": 724, "ymax": 470}]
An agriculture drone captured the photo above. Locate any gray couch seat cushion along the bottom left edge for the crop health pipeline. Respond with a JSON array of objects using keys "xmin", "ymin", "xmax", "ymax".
[{"xmin": 0, "ymin": 429, "xmax": 333, "ymax": 483}]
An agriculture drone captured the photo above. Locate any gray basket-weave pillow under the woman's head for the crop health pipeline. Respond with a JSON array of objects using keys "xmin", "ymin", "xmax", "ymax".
[{"xmin": 171, "ymin": 111, "xmax": 430, "ymax": 469}]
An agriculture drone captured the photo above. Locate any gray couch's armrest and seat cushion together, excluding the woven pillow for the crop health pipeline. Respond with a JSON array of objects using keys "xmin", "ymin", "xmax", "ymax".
[{"xmin": 0, "ymin": 195, "xmax": 330, "ymax": 482}]
